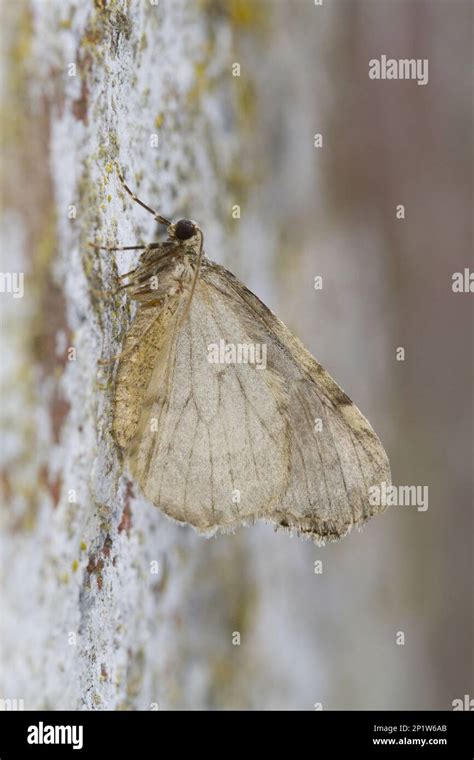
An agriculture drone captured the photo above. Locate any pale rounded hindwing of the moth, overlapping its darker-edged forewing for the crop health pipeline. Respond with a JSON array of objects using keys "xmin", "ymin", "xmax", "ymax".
[{"xmin": 122, "ymin": 270, "xmax": 288, "ymax": 533}]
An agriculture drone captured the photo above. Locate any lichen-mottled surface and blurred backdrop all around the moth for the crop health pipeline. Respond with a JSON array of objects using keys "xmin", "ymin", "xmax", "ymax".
[{"xmin": 0, "ymin": 0, "xmax": 474, "ymax": 710}]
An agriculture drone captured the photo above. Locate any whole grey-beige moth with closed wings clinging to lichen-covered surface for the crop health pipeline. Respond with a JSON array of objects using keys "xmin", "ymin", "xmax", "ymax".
[{"xmin": 95, "ymin": 169, "xmax": 391, "ymax": 543}]
